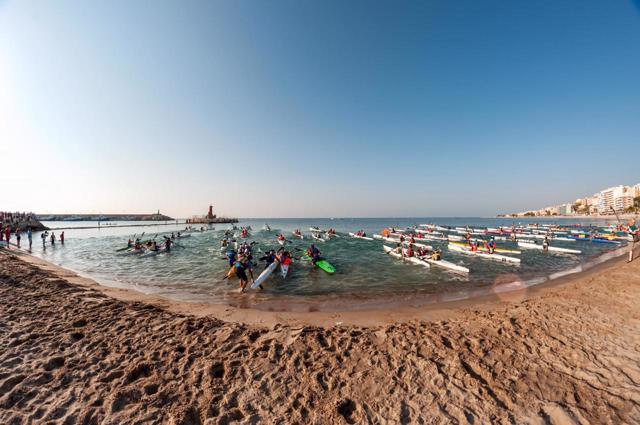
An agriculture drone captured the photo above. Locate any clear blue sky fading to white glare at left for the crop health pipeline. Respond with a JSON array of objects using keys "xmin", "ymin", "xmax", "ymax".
[{"xmin": 0, "ymin": 0, "xmax": 640, "ymax": 217}]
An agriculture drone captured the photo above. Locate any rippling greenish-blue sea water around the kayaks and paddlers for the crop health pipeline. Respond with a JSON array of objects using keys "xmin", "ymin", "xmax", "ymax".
[{"xmin": 23, "ymin": 217, "xmax": 621, "ymax": 311}]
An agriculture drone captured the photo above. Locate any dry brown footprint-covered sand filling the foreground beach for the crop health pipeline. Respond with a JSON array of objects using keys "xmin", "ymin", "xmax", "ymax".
[{"xmin": 0, "ymin": 252, "xmax": 640, "ymax": 424}]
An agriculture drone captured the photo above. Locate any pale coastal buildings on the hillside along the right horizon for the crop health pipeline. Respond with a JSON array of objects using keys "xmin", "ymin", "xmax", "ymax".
[{"xmin": 498, "ymin": 183, "xmax": 640, "ymax": 217}]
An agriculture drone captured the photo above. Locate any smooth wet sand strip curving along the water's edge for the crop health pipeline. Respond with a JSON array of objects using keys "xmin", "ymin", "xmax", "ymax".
[{"xmin": 6, "ymin": 240, "xmax": 640, "ymax": 327}]
